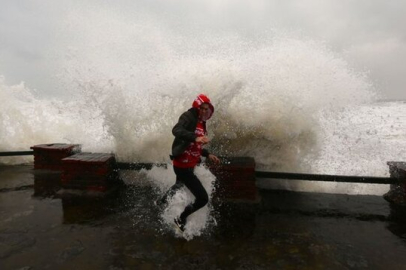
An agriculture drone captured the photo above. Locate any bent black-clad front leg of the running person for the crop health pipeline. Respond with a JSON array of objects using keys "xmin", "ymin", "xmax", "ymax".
[{"xmin": 174, "ymin": 167, "xmax": 209, "ymax": 225}]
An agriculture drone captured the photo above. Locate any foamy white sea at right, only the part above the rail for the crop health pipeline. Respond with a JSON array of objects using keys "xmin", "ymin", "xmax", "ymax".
[{"xmin": 312, "ymin": 102, "xmax": 406, "ymax": 176}]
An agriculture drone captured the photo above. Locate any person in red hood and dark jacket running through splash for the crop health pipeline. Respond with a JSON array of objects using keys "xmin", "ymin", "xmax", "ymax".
[{"xmin": 156, "ymin": 94, "xmax": 220, "ymax": 231}]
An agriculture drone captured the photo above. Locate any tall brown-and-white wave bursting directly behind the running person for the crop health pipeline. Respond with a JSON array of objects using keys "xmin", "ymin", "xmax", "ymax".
[{"xmin": 66, "ymin": 35, "xmax": 372, "ymax": 171}]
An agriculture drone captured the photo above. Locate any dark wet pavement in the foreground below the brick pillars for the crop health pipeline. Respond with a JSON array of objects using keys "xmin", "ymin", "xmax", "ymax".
[{"xmin": 0, "ymin": 166, "xmax": 406, "ymax": 269}]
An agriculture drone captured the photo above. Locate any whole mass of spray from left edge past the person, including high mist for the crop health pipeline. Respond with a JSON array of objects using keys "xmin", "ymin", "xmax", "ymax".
[{"xmin": 0, "ymin": 4, "xmax": 380, "ymax": 195}]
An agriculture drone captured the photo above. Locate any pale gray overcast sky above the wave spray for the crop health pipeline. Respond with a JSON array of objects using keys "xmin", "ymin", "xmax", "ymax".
[{"xmin": 0, "ymin": 0, "xmax": 406, "ymax": 99}]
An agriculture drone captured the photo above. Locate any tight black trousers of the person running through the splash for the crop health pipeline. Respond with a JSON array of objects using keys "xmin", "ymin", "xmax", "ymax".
[{"xmin": 161, "ymin": 166, "xmax": 209, "ymax": 222}]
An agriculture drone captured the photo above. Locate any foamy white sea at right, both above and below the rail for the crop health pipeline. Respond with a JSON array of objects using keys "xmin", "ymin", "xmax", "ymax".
[{"xmin": 259, "ymin": 101, "xmax": 406, "ymax": 195}]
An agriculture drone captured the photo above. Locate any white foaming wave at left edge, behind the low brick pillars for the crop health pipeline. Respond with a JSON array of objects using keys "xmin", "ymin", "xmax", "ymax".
[{"xmin": 0, "ymin": 77, "xmax": 113, "ymax": 164}]
